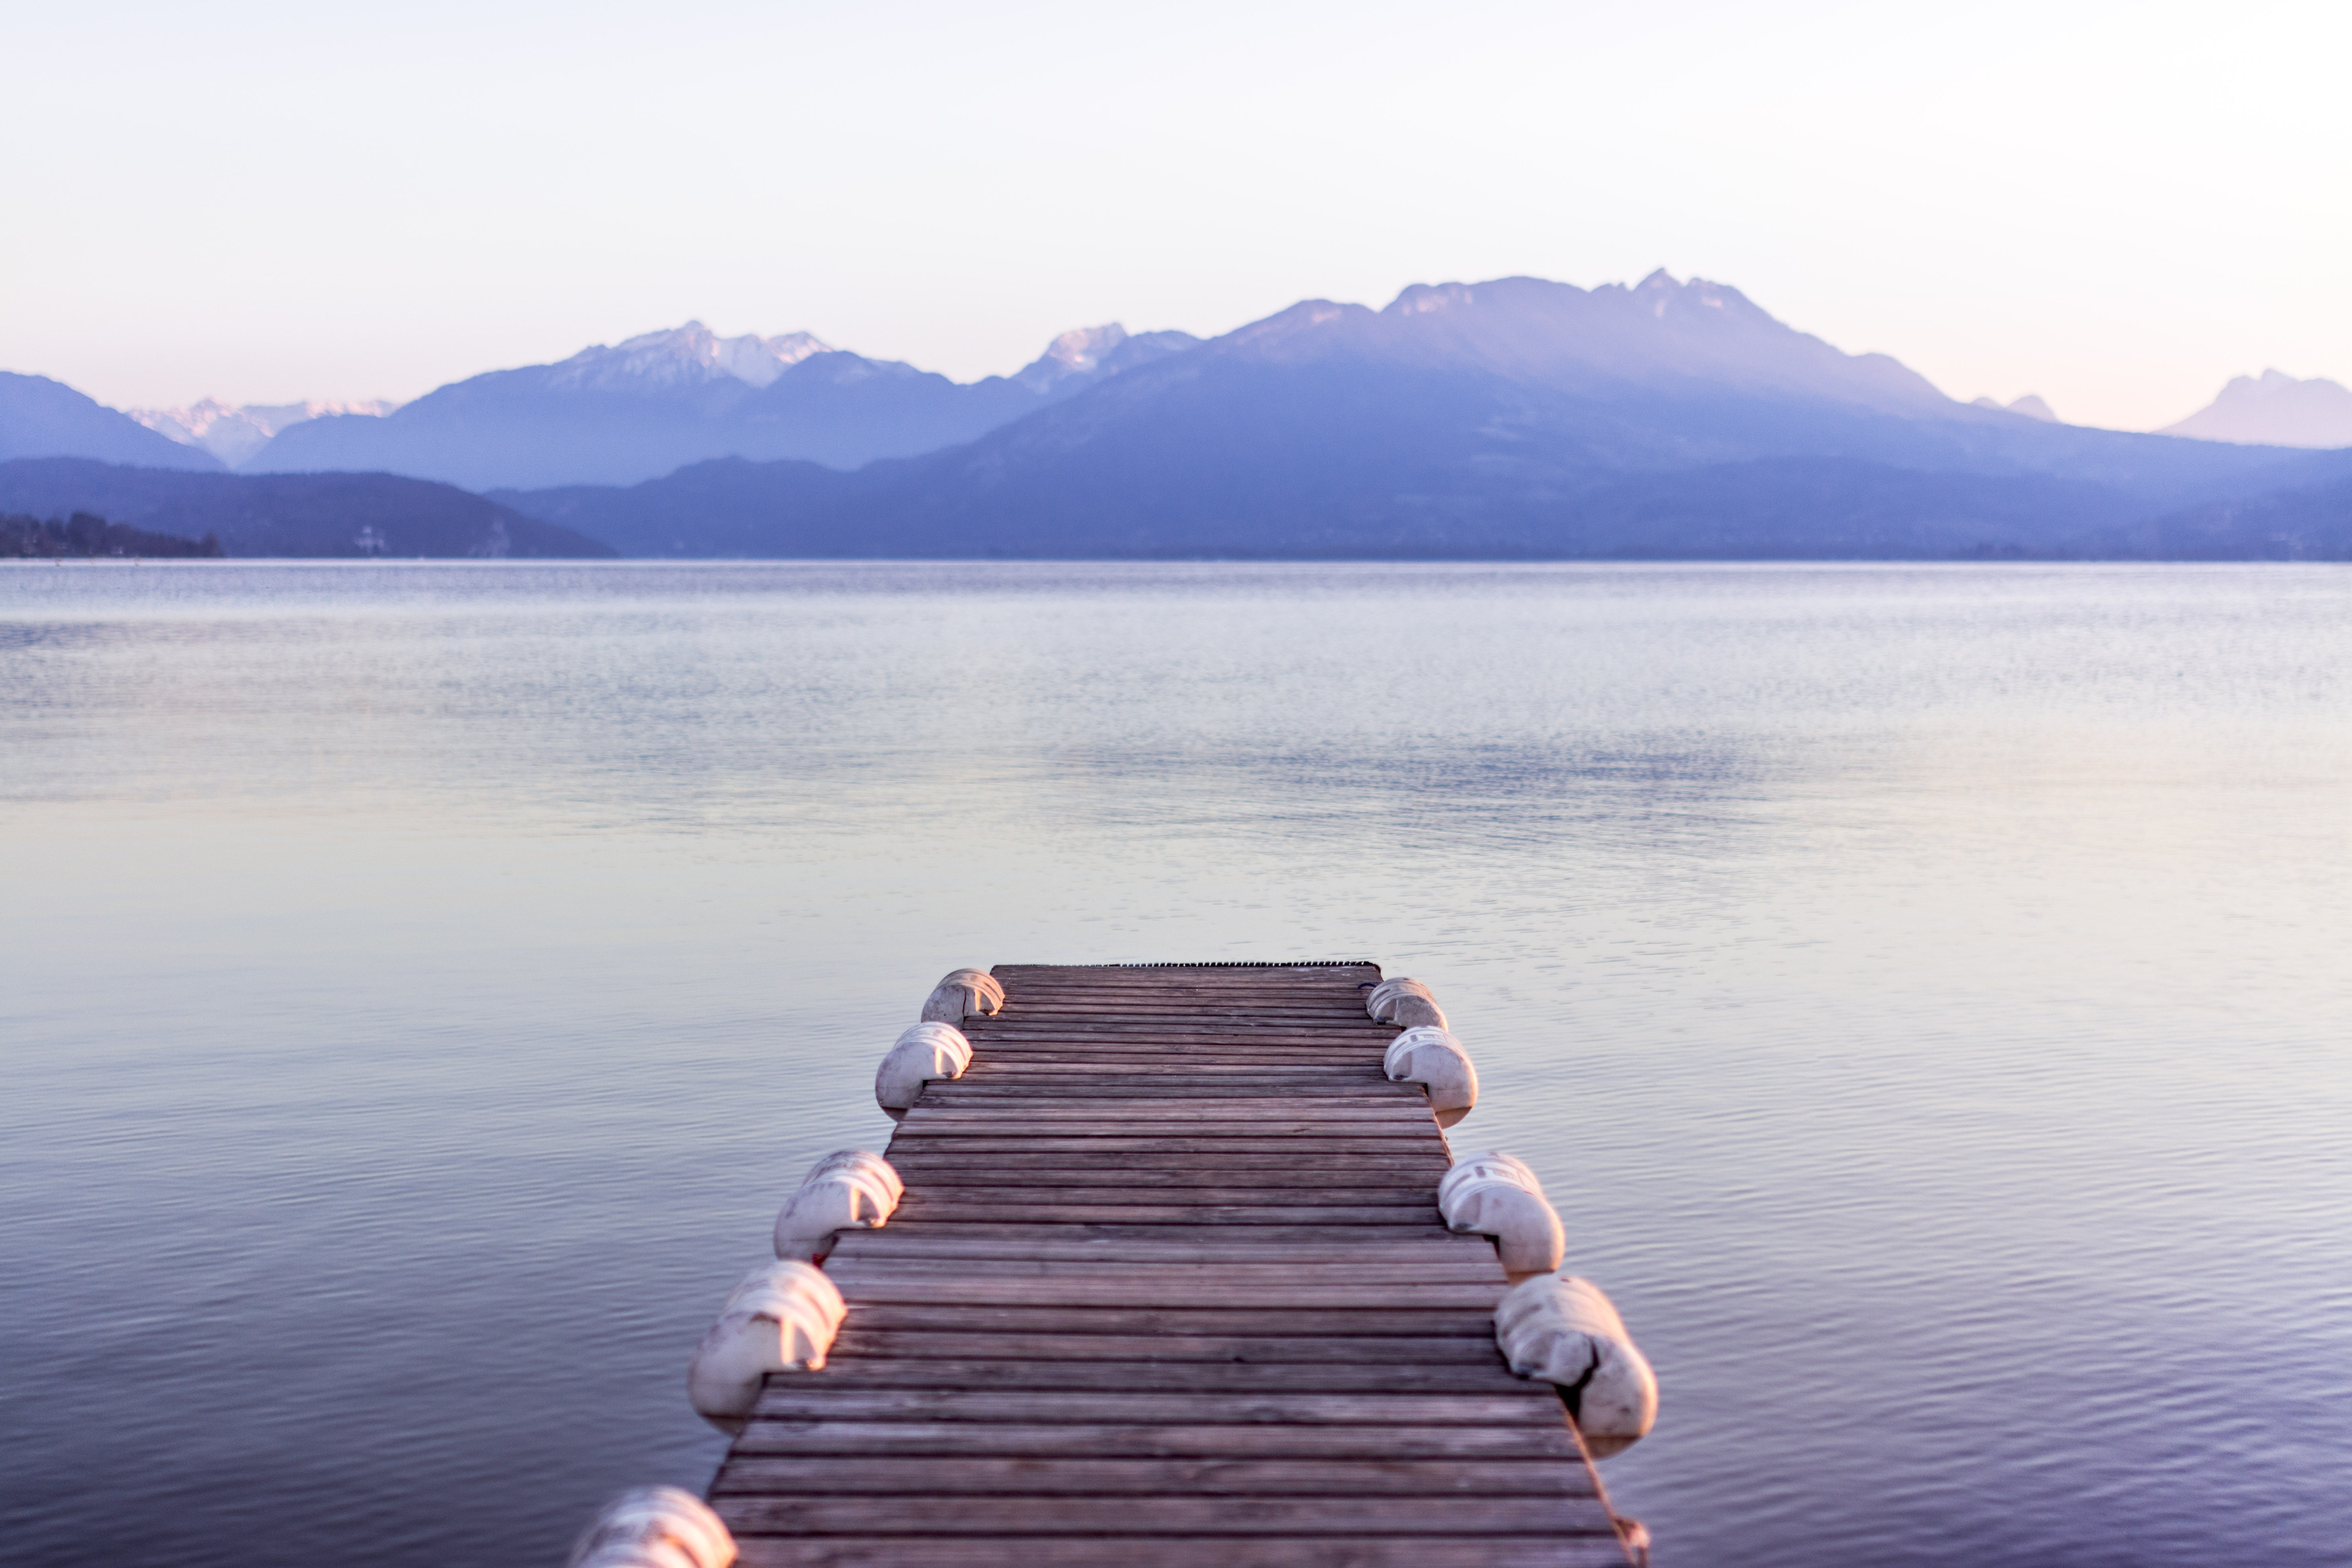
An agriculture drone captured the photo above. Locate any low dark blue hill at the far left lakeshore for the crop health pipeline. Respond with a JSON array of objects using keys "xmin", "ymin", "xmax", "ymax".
[{"xmin": 0, "ymin": 456, "xmax": 611, "ymax": 560}]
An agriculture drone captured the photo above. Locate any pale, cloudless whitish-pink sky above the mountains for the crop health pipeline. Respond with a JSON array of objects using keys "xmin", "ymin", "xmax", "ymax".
[{"xmin": 0, "ymin": 0, "xmax": 2352, "ymax": 428}]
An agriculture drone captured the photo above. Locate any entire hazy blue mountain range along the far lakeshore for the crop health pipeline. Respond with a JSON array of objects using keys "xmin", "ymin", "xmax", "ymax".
[{"xmin": 0, "ymin": 270, "xmax": 2352, "ymax": 560}]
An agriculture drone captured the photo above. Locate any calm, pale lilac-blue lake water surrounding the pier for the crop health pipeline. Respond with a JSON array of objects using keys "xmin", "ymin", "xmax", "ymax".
[{"xmin": 0, "ymin": 564, "xmax": 2352, "ymax": 1568}]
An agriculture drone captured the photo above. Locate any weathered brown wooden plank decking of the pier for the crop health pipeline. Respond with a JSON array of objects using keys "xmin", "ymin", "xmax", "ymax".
[{"xmin": 710, "ymin": 964, "xmax": 1627, "ymax": 1568}]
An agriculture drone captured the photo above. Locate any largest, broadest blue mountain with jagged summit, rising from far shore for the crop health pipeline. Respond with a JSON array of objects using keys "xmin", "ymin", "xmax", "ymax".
[{"xmin": 501, "ymin": 273, "xmax": 2315, "ymax": 557}]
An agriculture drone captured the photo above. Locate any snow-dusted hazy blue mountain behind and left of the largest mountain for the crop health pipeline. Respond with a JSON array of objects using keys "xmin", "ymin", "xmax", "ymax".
[{"xmin": 245, "ymin": 322, "xmax": 1195, "ymax": 489}]
